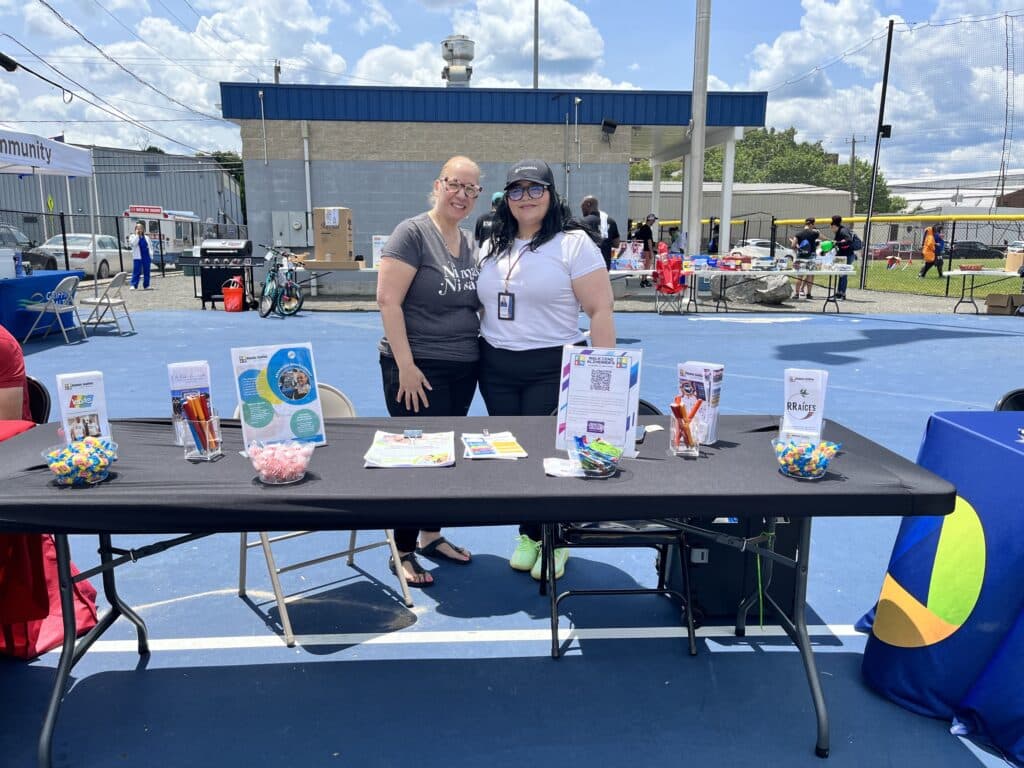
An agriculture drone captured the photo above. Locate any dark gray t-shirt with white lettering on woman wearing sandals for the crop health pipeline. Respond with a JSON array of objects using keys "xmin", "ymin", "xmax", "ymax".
[{"xmin": 381, "ymin": 213, "xmax": 480, "ymax": 360}]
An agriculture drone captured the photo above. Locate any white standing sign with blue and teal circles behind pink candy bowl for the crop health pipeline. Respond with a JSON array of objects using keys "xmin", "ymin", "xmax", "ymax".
[{"xmin": 231, "ymin": 342, "xmax": 327, "ymax": 445}]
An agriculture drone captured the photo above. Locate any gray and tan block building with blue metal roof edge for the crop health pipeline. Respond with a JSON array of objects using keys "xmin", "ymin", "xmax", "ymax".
[{"xmin": 221, "ymin": 83, "xmax": 767, "ymax": 292}]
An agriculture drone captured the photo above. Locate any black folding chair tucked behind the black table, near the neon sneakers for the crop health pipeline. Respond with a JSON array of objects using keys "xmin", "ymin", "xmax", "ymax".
[{"xmin": 541, "ymin": 400, "xmax": 697, "ymax": 658}]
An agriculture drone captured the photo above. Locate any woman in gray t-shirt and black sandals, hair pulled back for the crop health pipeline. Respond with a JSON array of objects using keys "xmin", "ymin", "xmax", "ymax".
[{"xmin": 377, "ymin": 157, "xmax": 483, "ymax": 587}]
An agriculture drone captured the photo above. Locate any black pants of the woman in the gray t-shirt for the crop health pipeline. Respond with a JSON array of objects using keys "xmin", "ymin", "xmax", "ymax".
[{"xmin": 381, "ymin": 354, "xmax": 479, "ymax": 552}]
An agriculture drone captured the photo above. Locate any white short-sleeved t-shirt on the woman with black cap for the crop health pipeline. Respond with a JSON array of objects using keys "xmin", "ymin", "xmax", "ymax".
[{"xmin": 476, "ymin": 231, "xmax": 605, "ymax": 351}]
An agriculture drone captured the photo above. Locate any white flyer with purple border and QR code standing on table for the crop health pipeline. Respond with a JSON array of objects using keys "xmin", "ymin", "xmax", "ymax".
[{"xmin": 555, "ymin": 345, "xmax": 643, "ymax": 457}]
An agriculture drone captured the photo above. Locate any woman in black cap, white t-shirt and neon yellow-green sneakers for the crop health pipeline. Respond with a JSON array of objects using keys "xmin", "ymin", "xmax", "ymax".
[{"xmin": 476, "ymin": 160, "xmax": 615, "ymax": 580}]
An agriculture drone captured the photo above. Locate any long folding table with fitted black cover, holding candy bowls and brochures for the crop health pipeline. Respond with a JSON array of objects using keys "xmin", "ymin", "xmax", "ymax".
[{"xmin": 0, "ymin": 416, "xmax": 955, "ymax": 766}]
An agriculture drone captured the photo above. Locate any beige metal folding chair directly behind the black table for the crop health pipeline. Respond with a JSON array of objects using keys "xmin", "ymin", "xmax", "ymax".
[{"xmin": 234, "ymin": 384, "xmax": 413, "ymax": 647}]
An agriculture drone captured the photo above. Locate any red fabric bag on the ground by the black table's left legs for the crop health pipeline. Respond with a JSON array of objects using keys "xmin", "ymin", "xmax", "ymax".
[{"xmin": 0, "ymin": 534, "xmax": 96, "ymax": 658}]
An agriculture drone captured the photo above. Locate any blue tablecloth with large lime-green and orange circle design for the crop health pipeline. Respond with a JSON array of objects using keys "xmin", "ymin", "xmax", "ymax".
[{"xmin": 863, "ymin": 412, "xmax": 1024, "ymax": 766}]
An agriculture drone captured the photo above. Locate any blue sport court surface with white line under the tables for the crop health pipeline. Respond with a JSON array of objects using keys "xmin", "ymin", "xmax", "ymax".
[{"xmin": 0, "ymin": 310, "xmax": 1024, "ymax": 768}]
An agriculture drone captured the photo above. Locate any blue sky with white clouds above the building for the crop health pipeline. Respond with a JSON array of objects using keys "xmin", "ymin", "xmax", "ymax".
[{"xmin": 0, "ymin": 0, "xmax": 1024, "ymax": 178}]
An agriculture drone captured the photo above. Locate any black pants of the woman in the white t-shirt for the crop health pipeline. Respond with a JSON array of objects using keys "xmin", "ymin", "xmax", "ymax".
[{"xmin": 480, "ymin": 338, "xmax": 562, "ymax": 542}]
